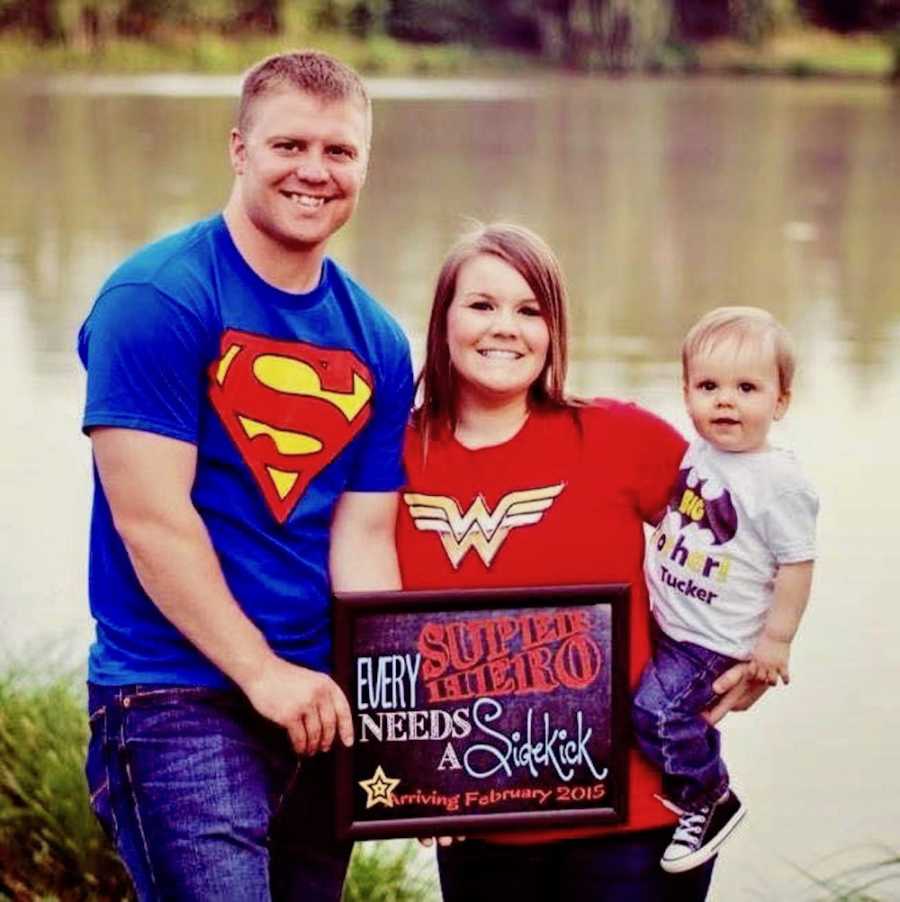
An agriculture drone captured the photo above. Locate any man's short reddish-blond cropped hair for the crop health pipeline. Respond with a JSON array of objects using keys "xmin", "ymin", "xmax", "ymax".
[{"xmin": 237, "ymin": 50, "xmax": 372, "ymax": 143}]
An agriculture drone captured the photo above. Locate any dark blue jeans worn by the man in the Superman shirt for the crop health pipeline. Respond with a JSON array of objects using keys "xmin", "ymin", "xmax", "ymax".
[{"xmin": 86, "ymin": 684, "xmax": 351, "ymax": 902}]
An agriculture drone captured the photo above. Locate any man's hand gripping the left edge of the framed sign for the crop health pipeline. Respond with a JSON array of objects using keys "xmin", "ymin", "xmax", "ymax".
[{"xmin": 242, "ymin": 657, "xmax": 353, "ymax": 755}]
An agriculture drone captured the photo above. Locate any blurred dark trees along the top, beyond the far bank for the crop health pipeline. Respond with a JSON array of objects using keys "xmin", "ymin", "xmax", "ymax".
[{"xmin": 0, "ymin": 0, "xmax": 900, "ymax": 71}]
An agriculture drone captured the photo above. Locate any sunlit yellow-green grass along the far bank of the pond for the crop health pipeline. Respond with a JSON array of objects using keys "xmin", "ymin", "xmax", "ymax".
[{"xmin": 0, "ymin": 21, "xmax": 900, "ymax": 78}]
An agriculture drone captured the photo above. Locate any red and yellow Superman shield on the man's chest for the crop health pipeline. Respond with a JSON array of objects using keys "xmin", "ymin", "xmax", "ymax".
[{"xmin": 209, "ymin": 329, "xmax": 373, "ymax": 523}]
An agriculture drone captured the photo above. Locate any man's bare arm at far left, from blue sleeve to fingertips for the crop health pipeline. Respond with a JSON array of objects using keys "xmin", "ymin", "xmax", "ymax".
[{"xmin": 91, "ymin": 428, "xmax": 353, "ymax": 754}]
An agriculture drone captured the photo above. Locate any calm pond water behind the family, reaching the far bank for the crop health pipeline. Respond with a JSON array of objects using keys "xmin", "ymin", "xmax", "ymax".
[{"xmin": 0, "ymin": 77, "xmax": 900, "ymax": 902}]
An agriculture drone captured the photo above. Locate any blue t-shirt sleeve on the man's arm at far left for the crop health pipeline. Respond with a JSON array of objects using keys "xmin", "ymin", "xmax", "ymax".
[{"xmin": 78, "ymin": 284, "xmax": 209, "ymax": 442}]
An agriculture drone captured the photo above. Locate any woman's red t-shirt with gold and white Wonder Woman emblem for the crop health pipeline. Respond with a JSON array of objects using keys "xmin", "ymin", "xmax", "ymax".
[{"xmin": 397, "ymin": 400, "xmax": 686, "ymax": 843}]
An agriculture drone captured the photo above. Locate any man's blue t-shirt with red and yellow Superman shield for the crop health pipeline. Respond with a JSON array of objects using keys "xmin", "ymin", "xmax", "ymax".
[{"xmin": 78, "ymin": 215, "xmax": 412, "ymax": 686}]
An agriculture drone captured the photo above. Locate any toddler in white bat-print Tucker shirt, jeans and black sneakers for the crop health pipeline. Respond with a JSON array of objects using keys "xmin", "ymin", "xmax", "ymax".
[{"xmin": 633, "ymin": 307, "xmax": 818, "ymax": 873}]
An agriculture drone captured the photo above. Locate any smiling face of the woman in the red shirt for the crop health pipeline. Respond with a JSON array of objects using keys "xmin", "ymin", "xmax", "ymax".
[{"xmin": 447, "ymin": 254, "xmax": 550, "ymax": 403}]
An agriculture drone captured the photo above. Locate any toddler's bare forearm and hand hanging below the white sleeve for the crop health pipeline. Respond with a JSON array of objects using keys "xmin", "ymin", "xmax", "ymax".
[{"xmin": 747, "ymin": 561, "xmax": 813, "ymax": 686}]
